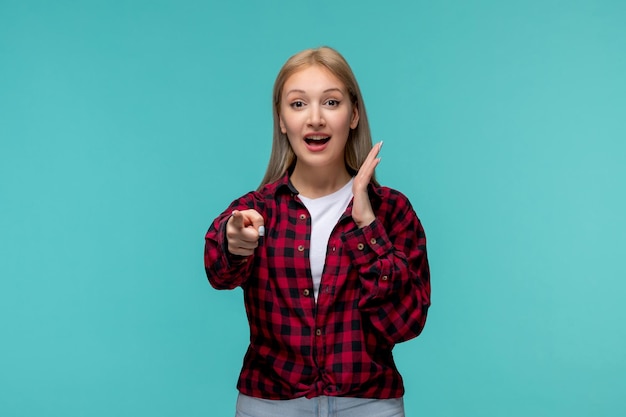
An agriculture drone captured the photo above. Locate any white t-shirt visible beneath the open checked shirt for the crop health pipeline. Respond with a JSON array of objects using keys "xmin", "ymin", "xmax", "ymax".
[{"xmin": 299, "ymin": 179, "xmax": 354, "ymax": 301}]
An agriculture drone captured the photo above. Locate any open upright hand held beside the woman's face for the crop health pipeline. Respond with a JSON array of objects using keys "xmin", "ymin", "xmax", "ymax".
[{"xmin": 352, "ymin": 141, "xmax": 383, "ymax": 228}]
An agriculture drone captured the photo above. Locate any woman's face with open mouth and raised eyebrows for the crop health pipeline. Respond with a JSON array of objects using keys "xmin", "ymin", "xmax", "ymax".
[{"xmin": 279, "ymin": 65, "xmax": 359, "ymax": 172}]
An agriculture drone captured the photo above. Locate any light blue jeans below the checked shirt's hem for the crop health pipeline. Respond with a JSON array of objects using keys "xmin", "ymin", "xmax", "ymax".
[{"xmin": 235, "ymin": 394, "xmax": 404, "ymax": 417}]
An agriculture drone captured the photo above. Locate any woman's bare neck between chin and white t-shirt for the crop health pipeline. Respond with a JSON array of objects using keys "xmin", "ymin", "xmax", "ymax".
[{"xmin": 289, "ymin": 163, "xmax": 352, "ymax": 198}]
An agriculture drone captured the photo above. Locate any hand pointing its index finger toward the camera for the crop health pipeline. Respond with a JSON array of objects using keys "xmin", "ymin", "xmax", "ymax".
[{"xmin": 226, "ymin": 209, "xmax": 265, "ymax": 256}]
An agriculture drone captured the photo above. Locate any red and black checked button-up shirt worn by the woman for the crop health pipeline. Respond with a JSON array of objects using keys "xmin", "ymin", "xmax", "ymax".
[{"xmin": 204, "ymin": 174, "xmax": 430, "ymax": 399}]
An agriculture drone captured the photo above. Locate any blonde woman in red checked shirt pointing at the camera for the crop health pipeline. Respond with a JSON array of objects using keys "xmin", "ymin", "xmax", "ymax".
[{"xmin": 204, "ymin": 47, "xmax": 430, "ymax": 417}]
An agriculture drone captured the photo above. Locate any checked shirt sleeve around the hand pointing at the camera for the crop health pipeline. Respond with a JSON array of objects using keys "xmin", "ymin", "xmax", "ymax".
[{"xmin": 204, "ymin": 193, "xmax": 263, "ymax": 289}]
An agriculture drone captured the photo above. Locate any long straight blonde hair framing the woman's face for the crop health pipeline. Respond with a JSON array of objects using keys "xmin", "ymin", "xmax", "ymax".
[{"xmin": 259, "ymin": 46, "xmax": 378, "ymax": 189}]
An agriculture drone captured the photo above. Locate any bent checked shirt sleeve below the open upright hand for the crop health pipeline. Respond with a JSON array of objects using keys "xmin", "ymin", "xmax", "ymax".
[{"xmin": 344, "ymin": 192, "xmax": 430, "ymax": 345}]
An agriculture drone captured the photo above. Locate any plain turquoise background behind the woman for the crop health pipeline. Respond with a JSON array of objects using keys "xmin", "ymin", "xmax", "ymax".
[{"xmin": 0, "ymin": 0, "xmax": 626, "ymax": 417}]
